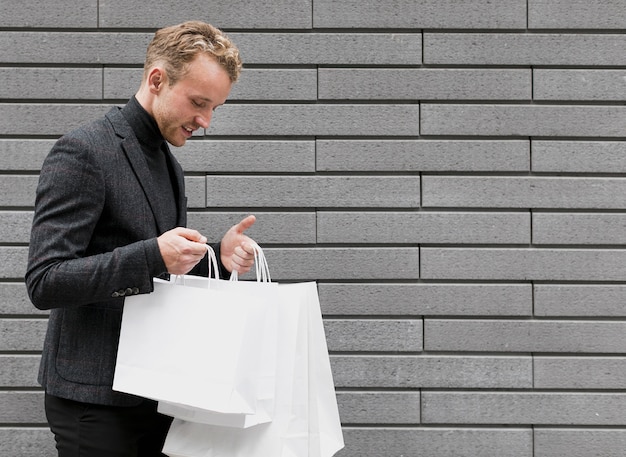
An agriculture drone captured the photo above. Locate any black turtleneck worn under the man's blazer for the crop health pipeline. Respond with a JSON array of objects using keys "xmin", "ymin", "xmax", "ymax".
[{"xmin": 122, "ymin": 96, "xmax": 178, "ymax": 230}]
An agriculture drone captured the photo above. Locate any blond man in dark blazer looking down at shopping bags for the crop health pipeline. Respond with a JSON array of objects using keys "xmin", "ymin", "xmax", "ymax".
[{"xmin": 26, "ymin": 22, "xmax": 255, "ymax": 457}]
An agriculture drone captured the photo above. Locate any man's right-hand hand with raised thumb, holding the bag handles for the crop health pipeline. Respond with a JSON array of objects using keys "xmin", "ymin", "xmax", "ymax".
[{"xmin": 220, "ymin": 215, "xmax": 256, "ymax": 274}]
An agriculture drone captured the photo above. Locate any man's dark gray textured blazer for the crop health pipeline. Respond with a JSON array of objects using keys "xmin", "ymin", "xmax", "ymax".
[{"xmin": 26, "ymin": 108, "xmax": 219, "ymax": 405}]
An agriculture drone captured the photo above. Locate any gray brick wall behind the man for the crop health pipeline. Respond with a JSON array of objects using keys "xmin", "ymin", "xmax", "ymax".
[{"xmin": 0, "ymin": 0, "xmax": 626, "ymax": 457}]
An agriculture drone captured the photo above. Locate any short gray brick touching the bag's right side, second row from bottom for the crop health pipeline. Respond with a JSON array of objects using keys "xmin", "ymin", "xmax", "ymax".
[{"xmin": 337, "ymin": 392, "xmax": 420, "ymax": 424}]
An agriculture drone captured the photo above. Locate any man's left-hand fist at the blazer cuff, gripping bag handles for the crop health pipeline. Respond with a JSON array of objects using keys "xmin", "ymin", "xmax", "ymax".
[{"xmin": 157, "ymin": 227, "xmax": 207, "ymax": 275}]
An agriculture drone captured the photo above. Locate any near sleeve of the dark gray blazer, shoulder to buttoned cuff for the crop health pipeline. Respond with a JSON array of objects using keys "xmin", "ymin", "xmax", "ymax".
[{"xmin": 25, "ymin": 135, "xmax": 166, "ymax": 309}]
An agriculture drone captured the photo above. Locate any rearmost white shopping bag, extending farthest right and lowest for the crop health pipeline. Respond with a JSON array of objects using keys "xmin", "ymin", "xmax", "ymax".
[{"xmin": 163, "ymin": 282, "xmax": 344, "ymax": 457}]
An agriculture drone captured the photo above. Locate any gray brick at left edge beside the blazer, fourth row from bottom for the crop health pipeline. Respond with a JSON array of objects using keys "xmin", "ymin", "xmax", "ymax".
[{"xmin": 0, "ymin": 319, "xmax": 48, "ymax": 351}]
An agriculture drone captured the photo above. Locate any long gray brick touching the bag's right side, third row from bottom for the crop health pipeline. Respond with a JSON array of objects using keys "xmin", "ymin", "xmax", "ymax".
[{"xmin": 331, "ymin": 355, "xmax": 533, "ymax": 389}]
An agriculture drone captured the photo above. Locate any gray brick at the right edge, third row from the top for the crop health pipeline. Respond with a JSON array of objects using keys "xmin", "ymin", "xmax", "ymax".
[{"xmin": 533, "ymin": 69, "xmax": 626, "ymax": 101}]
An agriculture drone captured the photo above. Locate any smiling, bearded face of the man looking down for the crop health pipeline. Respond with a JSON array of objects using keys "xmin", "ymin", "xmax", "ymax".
[{"xmin": 152, "ymin": 54, "xmax": 232, "ymax": 146}]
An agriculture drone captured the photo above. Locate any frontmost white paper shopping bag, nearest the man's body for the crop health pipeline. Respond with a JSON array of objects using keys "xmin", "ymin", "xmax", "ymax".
[{"xmin": 113, "ymin": 248, "xmax": 271, "ymax": 414}]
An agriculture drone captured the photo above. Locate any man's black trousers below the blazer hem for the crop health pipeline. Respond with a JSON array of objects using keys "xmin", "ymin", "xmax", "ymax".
[{"xmin": 45, "ymin": 394, "xmax": 172, "ymax": 457}]
